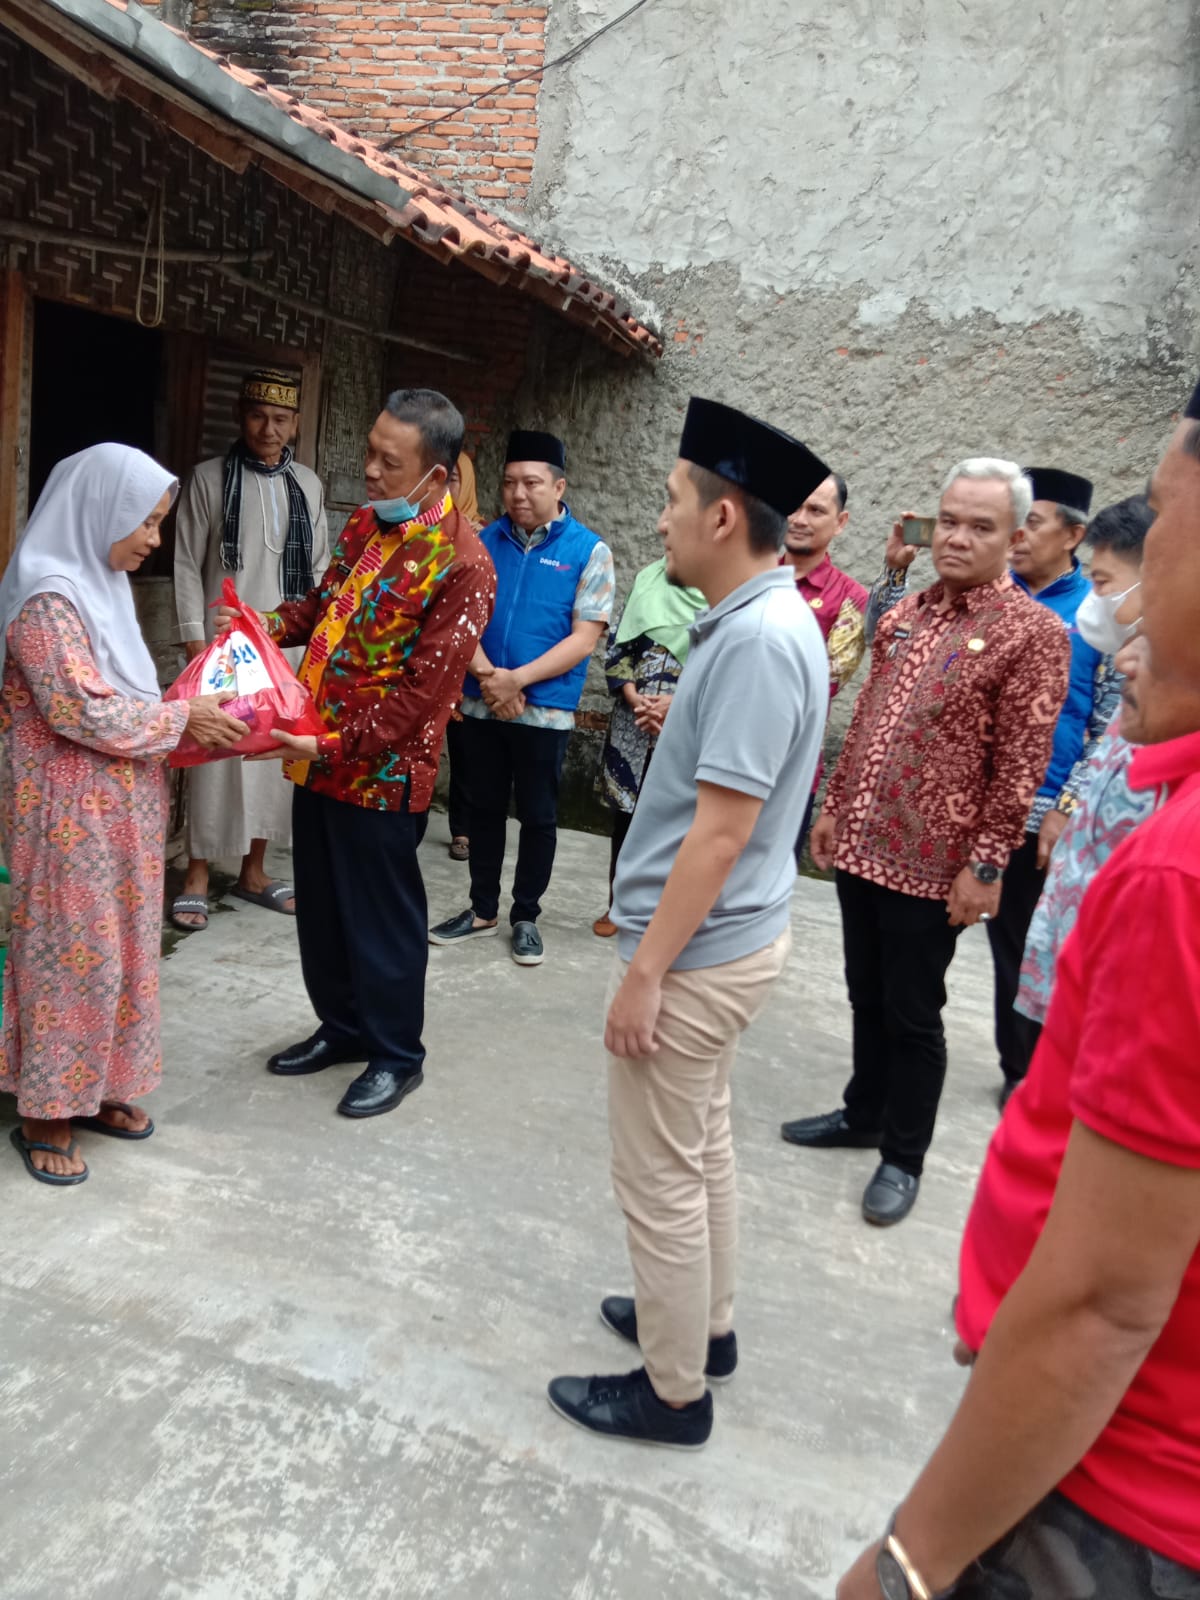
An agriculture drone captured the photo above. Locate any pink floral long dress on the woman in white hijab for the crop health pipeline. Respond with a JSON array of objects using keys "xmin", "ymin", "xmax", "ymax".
[{"xmin": 0, "ymin": 594, "xmax": 187, "ymax": 1120}]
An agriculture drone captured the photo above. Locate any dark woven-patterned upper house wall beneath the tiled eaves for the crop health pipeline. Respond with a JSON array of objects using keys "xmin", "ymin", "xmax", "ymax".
[{"xmin": 0, "ymin": 30, "xmax": 534, "ymax": 524}]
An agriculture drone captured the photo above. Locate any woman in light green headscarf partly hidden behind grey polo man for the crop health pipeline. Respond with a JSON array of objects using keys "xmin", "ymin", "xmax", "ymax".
[{"xmin": 592, "ymin": 557, "xmax": 707, "ymax": 939}]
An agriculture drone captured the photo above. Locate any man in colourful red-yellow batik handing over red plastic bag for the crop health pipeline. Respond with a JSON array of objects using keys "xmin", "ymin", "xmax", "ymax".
[{"xmin": 227, "ymin": 389, "xmax": 496, "ymax": 1117}]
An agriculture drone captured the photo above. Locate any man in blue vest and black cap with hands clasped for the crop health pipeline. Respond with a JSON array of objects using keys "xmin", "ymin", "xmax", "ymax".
[{"xmin": 429, "ymin": 429, "xmax": 616, "ymax": 966}]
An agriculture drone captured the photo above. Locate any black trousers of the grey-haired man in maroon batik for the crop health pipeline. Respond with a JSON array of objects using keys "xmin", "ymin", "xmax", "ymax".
[{"xmin": 837, "ymin": 870, "xmax": 962, "ymax": 1176}]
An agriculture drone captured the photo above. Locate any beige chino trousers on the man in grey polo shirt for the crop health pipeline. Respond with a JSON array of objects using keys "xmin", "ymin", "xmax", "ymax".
[{"xmin": 605, "ymin": 930, "xmax": 792, "ymax": 1403}]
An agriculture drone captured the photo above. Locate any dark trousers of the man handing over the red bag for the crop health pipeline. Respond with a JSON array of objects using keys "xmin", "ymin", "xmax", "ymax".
[{"xmin": 291, "ymin": 789, "xmax": 429, "ymax": 1072}]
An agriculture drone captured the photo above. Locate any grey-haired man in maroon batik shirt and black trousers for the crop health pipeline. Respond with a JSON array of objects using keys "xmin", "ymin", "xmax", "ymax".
[{"xmin": 782, "ymin": 456, "xmax": 1070, "ymax": 1227}]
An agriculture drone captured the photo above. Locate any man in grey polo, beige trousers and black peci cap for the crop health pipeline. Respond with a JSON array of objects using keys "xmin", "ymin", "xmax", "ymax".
[{"xmin": 549, "ymin": 400, "xmax": 829, "ymax": 1450}]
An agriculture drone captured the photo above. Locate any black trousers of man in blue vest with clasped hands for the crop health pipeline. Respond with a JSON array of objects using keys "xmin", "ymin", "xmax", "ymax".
[{"xmin": 462, "ymin": 717, "xmax": 571, "ymax": 923}]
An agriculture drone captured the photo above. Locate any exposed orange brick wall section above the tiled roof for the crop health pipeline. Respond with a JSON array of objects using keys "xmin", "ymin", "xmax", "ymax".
[{"xmin": 190, "ymin": 0, "xmax": 547, "ymax": 206}]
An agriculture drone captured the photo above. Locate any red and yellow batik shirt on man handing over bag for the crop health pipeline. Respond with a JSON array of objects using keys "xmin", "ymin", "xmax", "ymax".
[{"xmin": 267, "ymin": 496, "xmax": 496, "ymax": 811}]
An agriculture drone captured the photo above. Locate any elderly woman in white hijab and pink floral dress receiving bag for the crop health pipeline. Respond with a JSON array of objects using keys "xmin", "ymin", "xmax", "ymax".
[{"xmin": 0, "ymin": 445, "xmax": 246, "ymax": 1184}]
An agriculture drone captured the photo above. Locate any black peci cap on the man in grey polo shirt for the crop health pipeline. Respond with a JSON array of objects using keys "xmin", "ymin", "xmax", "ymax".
[{"xmin": 678, "ymin": 397, "xmax": 829, "ymax": 517}]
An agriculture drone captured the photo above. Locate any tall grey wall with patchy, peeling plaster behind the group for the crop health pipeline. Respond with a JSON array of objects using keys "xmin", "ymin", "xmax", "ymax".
[{"xmin": 522, "ymin": 0, "xmax": 1200, "ymax": 806}]
